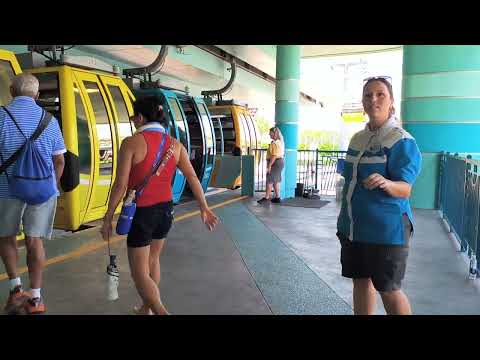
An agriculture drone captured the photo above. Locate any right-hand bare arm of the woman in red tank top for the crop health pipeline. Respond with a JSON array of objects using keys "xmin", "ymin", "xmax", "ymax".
[{"xmin": 177, "ymin": 143, "xmax": 218, "ymax": 231}]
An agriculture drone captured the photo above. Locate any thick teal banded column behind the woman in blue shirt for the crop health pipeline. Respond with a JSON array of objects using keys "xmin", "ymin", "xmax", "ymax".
[{"xmin": 401, "ymin": 45, "xmax": 480, "ymax": 209}]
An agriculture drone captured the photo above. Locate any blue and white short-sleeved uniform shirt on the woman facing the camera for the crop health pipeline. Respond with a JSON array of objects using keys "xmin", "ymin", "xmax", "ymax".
[{"xmin": 337, "ymin": 117, "xmax": 422, "ymax": 245}]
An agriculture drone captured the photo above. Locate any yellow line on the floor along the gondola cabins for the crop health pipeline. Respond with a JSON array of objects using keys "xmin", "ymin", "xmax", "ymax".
[{"xmin": 0, "ymin": 196, "xmax": 248, "ymax": 281}]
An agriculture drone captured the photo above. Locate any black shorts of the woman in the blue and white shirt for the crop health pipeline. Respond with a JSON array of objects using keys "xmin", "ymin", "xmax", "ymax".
[{"xmin": 337, "ymin": 216, "xmax": 413, "ymax": 291}]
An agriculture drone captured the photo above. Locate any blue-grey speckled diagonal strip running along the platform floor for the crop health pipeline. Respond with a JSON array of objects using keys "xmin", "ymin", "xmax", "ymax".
[{"xmin": 217, "ymin": 203, "xmax": 352, "ymax": 315}]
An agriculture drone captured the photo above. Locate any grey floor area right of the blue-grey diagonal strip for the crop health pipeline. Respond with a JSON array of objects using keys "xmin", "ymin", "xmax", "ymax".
[{"xmin": 248, "ymin": 198, "xmax": 480, "ymax": 315}]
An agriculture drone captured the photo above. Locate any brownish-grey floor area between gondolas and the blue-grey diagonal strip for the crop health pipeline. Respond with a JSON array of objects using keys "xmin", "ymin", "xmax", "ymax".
[{"xmin": 0, "ymin": 193, "xmax": 271, "ymax": 315}]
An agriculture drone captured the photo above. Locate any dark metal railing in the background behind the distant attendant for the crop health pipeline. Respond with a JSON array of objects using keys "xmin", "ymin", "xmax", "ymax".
[{"xmin": 252, "ymin": 149, "xmax": 346, "ymax": 195}]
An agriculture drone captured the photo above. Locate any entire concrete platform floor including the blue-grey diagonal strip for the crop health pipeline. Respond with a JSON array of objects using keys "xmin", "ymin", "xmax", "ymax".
[{"xmin": 0, "ymin": 191, "xmax": 480, "ymax": 315}]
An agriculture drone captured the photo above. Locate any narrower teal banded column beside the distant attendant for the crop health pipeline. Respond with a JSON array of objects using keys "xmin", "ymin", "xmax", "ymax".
[{"xmin": 275, "ymin": 45, "xmax": 300, "ymax": 198}]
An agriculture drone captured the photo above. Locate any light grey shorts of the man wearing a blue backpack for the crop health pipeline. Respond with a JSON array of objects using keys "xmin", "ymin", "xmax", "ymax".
[{"xmin": 0, "ymin": 195, "xmax": 57, "ymax": 240}]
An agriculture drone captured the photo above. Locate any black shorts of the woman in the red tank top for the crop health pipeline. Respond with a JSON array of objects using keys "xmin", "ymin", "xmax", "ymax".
[{"xmin": 127, "ymin": 201, "xmax": 173, "ymax": 247}]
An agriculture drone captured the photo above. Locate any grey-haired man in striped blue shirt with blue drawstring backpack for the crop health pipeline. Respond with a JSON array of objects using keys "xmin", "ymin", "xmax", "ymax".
[{"xmin": 0, "ymin": 74, "xmax": 66, "ymax": 314}]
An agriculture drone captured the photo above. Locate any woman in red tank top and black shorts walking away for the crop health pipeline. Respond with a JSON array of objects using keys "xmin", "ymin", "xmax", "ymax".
[{"xmin": 101, "ymin": 96, "xmax": 218, "ymax": 315}]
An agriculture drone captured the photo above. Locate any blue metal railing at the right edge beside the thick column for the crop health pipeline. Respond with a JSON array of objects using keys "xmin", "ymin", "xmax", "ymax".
[{"xmin": 438, "ymin": 153, "xmax": 480, "ymax": 278}]
